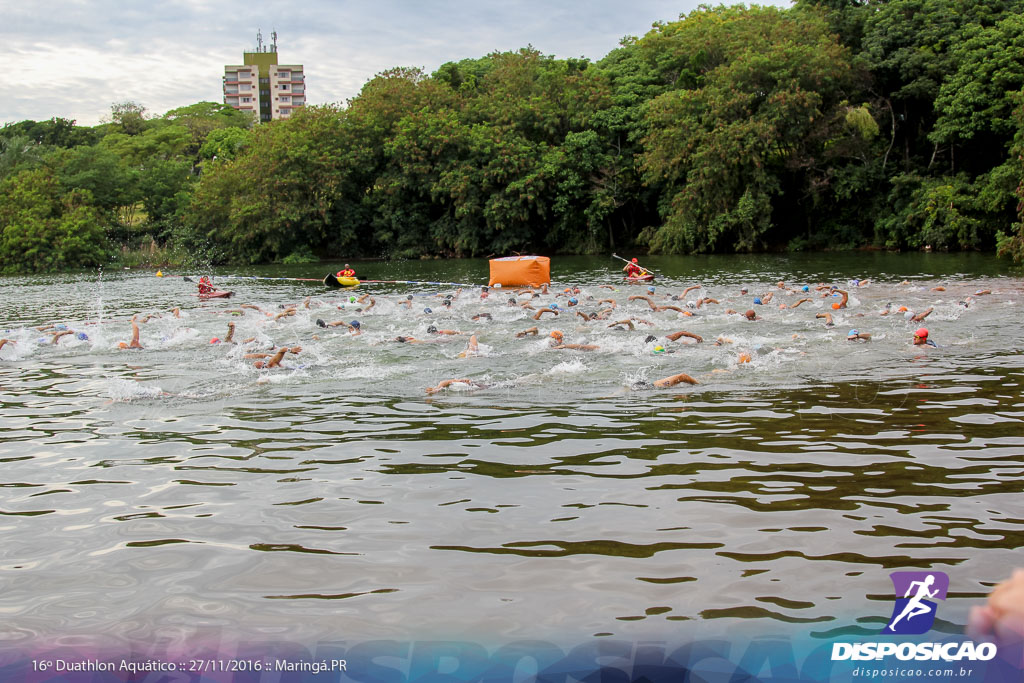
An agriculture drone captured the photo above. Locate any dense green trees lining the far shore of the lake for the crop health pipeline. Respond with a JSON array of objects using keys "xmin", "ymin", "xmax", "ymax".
[{"xmin": 0, "ymin": 0, "xmax": 1024, "ymax": 271}]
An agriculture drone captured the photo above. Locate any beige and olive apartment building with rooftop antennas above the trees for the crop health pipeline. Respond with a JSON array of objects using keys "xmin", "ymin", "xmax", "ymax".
[{"xmin": 223, "ymin": 32, "xmax": 306, "ymax": 122}]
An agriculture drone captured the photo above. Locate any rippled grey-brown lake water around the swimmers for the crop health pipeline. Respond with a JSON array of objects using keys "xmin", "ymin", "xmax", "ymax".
[{"xmin": 0, "ymin": 255, "xmax": 1024, "ymax": 643}]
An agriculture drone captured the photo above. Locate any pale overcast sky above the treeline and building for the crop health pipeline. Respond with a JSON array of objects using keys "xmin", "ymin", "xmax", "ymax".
[{"xmin": 0, "ymin": 0, "xmax": 788, "ymax": 126}]
